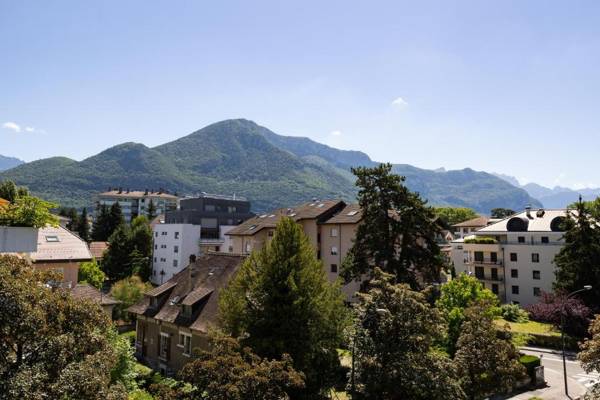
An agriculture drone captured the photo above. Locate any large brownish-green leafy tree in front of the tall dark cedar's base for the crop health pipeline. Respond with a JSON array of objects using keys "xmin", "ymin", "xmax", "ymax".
[{"xmin": 349, "ymin": 269, "xmax": 464, "ymax": 400}]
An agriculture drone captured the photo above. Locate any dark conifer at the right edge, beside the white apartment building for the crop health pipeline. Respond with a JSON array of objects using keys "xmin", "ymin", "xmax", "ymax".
[{"xmin": 554, "ymin": 200, "xmax": 600, "ymax": 307}]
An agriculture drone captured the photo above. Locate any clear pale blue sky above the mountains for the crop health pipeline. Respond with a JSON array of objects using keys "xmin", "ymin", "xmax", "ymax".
[{"xmin": 0, "ymin": 0, "xmax": 600, "ymax": 188}]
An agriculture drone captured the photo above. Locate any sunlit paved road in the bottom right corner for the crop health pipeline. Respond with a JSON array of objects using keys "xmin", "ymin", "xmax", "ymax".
[{"xmin": 511, "ymin": 348, "xmax": 600, "ymax": 400}]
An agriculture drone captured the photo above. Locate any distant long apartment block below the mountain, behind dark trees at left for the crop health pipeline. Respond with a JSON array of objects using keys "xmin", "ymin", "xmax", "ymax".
[{"xmin": 98, "ymin": 188, "xmax": 179, "ymax": 222}]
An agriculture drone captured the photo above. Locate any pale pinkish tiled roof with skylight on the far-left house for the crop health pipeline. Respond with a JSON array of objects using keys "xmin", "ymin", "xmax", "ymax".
[{"xmin": 29, "ymin": 226, "xmax": 92, "ymax": 263}]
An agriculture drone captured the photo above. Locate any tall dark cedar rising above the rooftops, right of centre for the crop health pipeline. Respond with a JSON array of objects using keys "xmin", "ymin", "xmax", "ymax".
[{"xmin": 342, "ymin": 164, "xmax": 444, "ymax": 288}]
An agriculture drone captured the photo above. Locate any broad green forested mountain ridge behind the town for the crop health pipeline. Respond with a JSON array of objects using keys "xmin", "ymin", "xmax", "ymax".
[{"xmin": 0, "ymin": 119, "xmax": 538, "ymax": 213}]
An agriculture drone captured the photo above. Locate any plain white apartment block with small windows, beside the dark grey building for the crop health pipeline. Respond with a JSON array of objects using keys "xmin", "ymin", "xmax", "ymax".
[{"xmin": 150, "ymin": 224, "xmax": 200, "ymax": 285}]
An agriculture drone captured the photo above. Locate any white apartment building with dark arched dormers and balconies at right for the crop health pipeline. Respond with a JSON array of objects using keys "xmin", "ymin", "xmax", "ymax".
[{"xmin": 452, "ymin": 208, "xmax": 567, "ymax": 305}]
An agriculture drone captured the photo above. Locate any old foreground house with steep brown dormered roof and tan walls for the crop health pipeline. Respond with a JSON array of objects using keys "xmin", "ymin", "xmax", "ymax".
[{"xmin": 128, "ymin": 253, "xmax": 244, "ymax": 375}]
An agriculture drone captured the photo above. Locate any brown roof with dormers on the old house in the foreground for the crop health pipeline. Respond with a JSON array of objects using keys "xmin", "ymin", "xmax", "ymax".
[{"xmin": 127, "ymin": 253, "xmax": 245, "ymax": 332}]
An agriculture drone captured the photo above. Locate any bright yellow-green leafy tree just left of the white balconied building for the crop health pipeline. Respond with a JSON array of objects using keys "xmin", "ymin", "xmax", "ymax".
[{"xmin": 436, "ymin": 273, "xmax": 499, "ymax": 355}]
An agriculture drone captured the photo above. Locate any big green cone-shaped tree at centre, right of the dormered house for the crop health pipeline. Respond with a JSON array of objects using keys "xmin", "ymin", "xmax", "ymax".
[{"xmin": 219, "ymin": 218, "xmax": 348, "ymax": 399}]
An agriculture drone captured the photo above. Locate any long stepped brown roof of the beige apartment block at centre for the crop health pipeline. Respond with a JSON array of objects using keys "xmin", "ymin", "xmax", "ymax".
[{"xmin": 226, "ymin": 200, "xmax": 345, "ymax": 236}]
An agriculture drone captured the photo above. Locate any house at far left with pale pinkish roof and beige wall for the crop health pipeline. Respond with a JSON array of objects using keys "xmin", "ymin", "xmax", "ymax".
[{"xmin": 27, "ymin": 226, "xmax": 92, "ymax": 286}]
